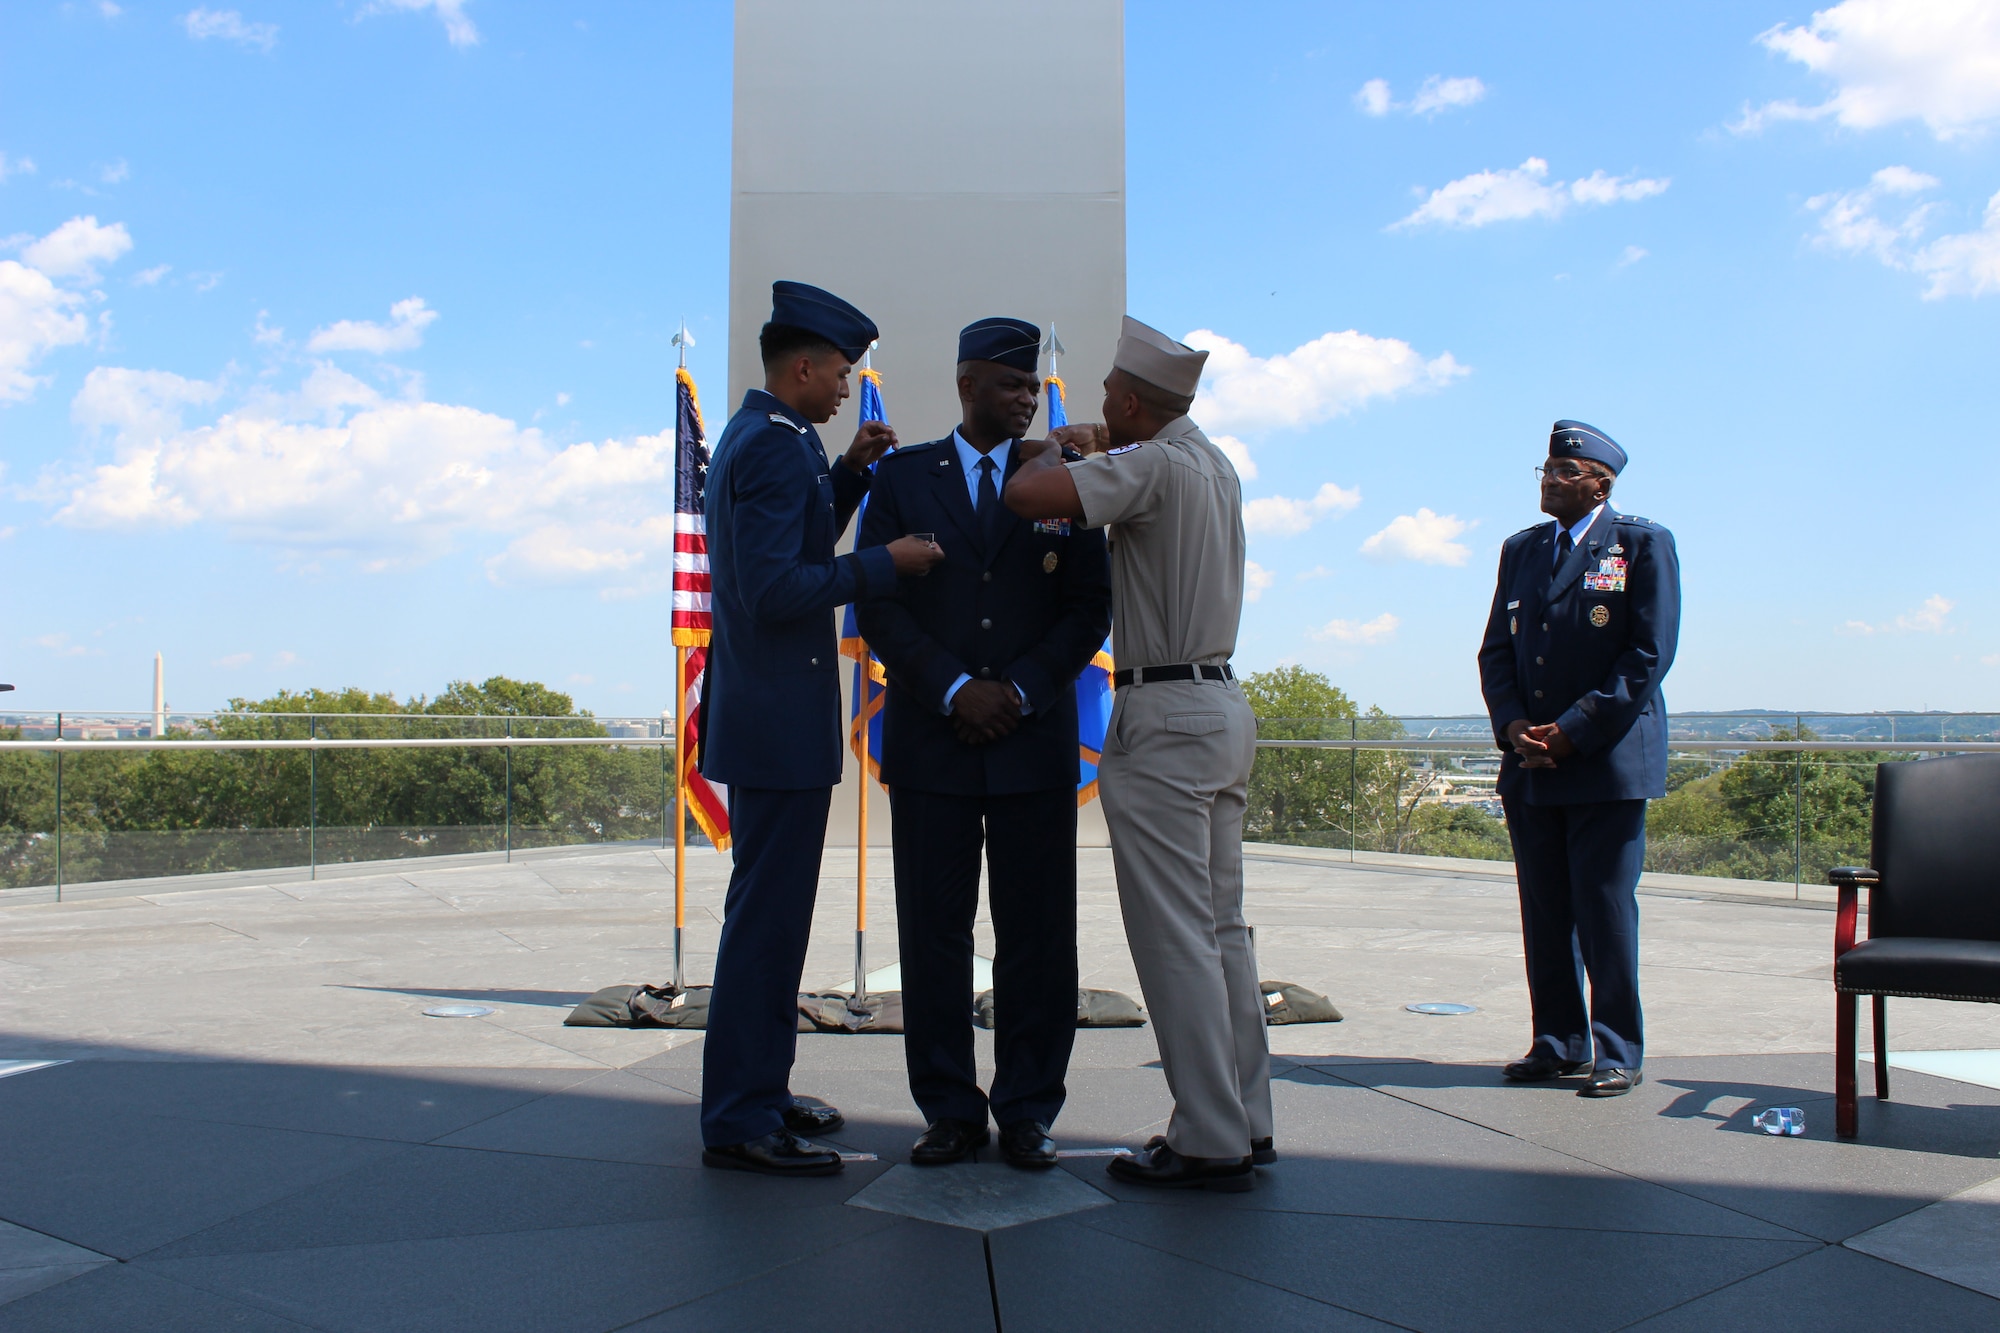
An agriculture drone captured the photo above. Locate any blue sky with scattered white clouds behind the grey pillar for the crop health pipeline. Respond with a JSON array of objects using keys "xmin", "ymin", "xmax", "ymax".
[{"xmin": 0, "ymin": 0, "xmax": 2000, "ymax": 713}]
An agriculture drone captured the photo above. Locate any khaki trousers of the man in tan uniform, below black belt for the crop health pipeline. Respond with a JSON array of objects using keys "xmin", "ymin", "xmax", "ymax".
[{"xmin": 1098, "ymin": 681, "xmax": 1272, "ymax": 1157}]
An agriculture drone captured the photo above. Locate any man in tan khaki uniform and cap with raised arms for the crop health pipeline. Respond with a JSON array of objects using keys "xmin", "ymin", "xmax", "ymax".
[{"xmin": 1006, "ymin": 318, "xmax": 1276, "ymax": 1191}]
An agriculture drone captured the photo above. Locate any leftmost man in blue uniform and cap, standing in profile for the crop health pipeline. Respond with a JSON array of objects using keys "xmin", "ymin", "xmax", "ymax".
[{"xmin": 700, "ymin": 282, "xmax": 942, "ymax": 1175}]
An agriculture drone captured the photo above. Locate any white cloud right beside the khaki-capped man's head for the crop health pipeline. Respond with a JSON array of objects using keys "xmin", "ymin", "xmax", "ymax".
[{"xmin": 1182, "ymin": 328, "xmax": 1468, "ymax": 438}]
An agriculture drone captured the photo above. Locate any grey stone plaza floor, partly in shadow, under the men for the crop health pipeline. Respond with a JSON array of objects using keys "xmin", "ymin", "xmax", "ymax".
[{"xmin": 0, "ymin": 847, "xmax": 2000, "ymax": 1333}]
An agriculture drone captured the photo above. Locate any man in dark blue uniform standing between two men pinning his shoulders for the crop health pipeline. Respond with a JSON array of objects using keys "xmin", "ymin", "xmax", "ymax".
[{"xmin": 856, "ymin": 318, "xmax": 1112, "ymax": 1169}]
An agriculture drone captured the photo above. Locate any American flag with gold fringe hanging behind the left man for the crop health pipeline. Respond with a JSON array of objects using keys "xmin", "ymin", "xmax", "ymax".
[{"xmin": 674, "ymin": 366, "xmax": 730, "ymax": 849}]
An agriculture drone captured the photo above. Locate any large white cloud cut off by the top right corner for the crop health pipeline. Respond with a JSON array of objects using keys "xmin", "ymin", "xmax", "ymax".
[{"xmin": 1730, "ymin": 0, "xmax": 2000, "ymax": 138}]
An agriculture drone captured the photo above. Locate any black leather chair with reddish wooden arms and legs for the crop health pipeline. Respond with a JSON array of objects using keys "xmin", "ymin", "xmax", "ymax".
[{"xmin": 1828, "ymin": 755, "xmax": 2000, "ymax": 1139}]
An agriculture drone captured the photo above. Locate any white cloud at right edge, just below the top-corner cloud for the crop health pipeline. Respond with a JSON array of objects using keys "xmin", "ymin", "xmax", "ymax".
[{"xmin": 1806, "ymin": 166, "xmax": 2000, "ymax": 300}]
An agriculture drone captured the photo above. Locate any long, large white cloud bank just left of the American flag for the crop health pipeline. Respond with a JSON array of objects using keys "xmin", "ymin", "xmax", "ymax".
[{"xmin": 45, "ymin": 362, "xmax": 674, "ymax": 586}]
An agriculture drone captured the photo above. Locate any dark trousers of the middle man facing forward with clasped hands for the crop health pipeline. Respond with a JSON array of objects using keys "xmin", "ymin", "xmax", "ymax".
[{"xmin": 890, "ymin": 787, "xmax": 1076, "ymax": 1129}]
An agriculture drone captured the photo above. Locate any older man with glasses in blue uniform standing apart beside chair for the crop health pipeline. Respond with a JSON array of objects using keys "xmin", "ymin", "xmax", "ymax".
[{"xmin": 1480, "ymin": 420, "xmax": 1680, "ymax": 1097}]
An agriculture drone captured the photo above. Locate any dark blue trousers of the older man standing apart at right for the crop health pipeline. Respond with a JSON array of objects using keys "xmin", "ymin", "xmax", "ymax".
[{"xmin": 1502, "ymin": 797, "xmax": 1646, "ymax": 1069}]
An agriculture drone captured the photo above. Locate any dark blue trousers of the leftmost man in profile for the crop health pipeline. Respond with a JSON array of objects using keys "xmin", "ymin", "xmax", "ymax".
[{"xmin": 702, "ymin": 787, "xmax": 834, "ymax": 1147}]
